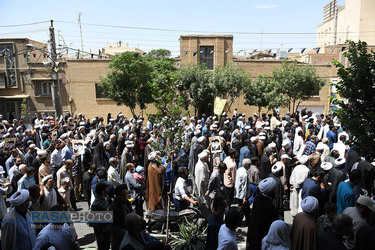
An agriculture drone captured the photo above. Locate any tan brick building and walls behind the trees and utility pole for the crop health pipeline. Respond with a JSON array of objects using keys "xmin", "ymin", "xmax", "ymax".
[{"xmin": 0, "ymin": 35, "xmax": 336, "ymax": 119}]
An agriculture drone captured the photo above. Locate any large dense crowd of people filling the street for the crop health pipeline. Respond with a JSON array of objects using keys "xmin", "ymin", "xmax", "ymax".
[{"xmin": 0, "ymin": 108, "xmax": 375, "ymax": 250}]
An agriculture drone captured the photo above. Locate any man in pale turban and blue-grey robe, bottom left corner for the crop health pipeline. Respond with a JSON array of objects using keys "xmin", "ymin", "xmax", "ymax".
[{"xmin": 1, "ymin": 189, "xmax": 35, "ymax": 249}]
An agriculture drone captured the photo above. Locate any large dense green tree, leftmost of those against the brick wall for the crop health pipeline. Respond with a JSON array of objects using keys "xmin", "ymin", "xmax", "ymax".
[{"xmin": 100, "ymin": 52, "xmax": 153, "ymax": 116}]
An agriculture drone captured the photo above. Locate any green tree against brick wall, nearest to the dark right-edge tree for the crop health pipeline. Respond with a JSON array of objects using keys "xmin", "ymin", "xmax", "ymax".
[{"xmin": 273, "ymin": 61, "xmax": 325, "ymax": 112}]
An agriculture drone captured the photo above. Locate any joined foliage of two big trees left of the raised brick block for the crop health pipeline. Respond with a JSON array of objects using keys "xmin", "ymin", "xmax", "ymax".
[{"xmin": 100, "ymin": 49, "xmax": 177, "ymax": 118}]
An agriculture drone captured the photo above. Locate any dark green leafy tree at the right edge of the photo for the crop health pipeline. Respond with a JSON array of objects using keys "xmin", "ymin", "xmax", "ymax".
[{"xmin": 333, "ymin": 41, "xmax": 375, "ymax": 156}]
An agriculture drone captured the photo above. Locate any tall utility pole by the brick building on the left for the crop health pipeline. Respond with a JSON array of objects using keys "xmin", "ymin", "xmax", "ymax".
[{"xmin": 49, "ymin": 20, "xmax": 62, "ymax": 118}]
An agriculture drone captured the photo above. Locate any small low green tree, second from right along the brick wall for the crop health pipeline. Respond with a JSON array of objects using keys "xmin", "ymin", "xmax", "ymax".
[{"xmin": 244, "ymin": 75, "xmax": 286, "ymax": 114}]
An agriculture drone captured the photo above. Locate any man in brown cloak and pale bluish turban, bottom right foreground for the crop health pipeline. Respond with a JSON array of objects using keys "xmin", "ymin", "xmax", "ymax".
[{"xmin": 290, "ymin": 196, "xmax": 319, "ymax": 250}]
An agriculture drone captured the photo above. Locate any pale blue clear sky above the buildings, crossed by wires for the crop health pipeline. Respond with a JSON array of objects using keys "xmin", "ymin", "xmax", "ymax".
[{"xmin": 0, "ymin": 0, "xmax": 345, "ymax": 55}]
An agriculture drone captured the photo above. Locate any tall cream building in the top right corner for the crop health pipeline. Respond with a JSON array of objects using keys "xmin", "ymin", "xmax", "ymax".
[{"xmin": 317, "ymin": 0, "xmax": 375, "ymax": 49}]
